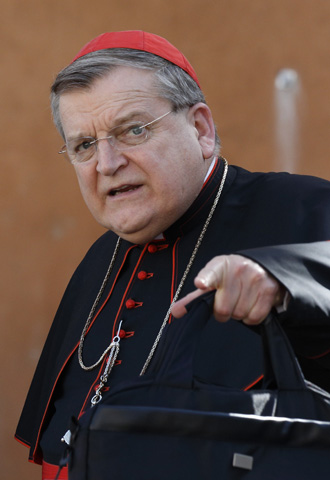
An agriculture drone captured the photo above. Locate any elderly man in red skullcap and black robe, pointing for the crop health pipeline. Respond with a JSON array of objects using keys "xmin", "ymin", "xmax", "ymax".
[{"xmin": 17, "ymin": 31, "xmax": 330, "ymax": 478}]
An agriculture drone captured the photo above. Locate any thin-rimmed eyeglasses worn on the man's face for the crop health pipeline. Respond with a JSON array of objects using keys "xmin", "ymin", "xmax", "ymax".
[{"xmin": 58, "ymin": 110, "xmax": 172, "ymax": 164}]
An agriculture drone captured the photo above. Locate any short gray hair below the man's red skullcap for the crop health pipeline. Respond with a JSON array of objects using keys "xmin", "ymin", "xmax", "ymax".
[{"xmin": 51, "ymin": 48, "xmax": 220, "ymax": 154}]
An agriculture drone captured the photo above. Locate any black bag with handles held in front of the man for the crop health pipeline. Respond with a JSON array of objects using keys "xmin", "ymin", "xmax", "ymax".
[{"xmin": 69, "ymin": 296, "xmax": 330, "ymax": 480}]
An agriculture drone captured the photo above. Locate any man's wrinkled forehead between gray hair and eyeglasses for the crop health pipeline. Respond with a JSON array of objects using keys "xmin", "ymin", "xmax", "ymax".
[{"xmin": 59, "ymin": 66, "xmax": 170, "ymax": 136}]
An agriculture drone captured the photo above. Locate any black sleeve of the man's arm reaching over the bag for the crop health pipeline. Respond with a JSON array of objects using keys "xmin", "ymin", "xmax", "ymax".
[{"xmin": 238, "ymin": 241, "xmax": 330, "ymax": 388}]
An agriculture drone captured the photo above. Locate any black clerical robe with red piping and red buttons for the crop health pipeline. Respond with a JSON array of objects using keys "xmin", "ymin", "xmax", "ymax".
[{"xmin": 16, "ymin": 159, "xmax": 330, "ymax": 463}]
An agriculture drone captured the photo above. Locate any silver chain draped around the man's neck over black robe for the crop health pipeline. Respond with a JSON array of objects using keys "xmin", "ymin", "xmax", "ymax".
[{"xmin": 78, "ymin": 159, "xmax": 228, "ymax": 384}]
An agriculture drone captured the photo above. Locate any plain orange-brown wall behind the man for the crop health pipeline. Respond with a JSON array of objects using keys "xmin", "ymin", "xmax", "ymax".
[{"xmin": 0, "ymin": 0, "xmax": 330, "ymax": 480}]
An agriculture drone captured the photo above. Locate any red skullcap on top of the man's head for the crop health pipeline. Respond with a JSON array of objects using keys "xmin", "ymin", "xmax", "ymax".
[{"xmin": 71, "ymin": 30, "xmax": 200, "ymax": 87}]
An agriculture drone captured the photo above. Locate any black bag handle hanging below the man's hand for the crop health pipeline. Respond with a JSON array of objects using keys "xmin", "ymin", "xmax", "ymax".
[{"xmin": 152, "ymin": 291, "xmax": 308, "ymax": 390}]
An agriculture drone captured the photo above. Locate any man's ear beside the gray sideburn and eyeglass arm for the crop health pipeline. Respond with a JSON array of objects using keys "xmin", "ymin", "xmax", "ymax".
[{"xmin": 189, "ymin": 102, "xmax": 215, "ymax": 159}]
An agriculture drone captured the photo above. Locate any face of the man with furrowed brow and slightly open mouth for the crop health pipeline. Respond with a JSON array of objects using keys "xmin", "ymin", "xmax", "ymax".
[{"xmin": 60, "ymin": 67, "xmax": 214, "ymax": 243}]
